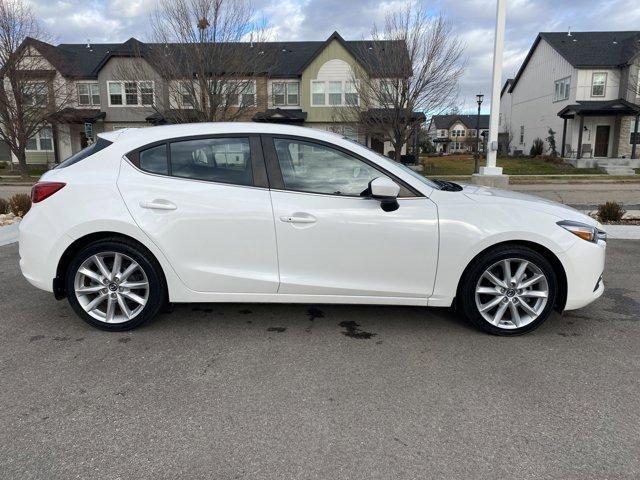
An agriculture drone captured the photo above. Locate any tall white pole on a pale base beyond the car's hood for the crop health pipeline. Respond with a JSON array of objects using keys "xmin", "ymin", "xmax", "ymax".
[{"xmin": 480, "ymin": 0, "xmax": 507, "ymax": 175}]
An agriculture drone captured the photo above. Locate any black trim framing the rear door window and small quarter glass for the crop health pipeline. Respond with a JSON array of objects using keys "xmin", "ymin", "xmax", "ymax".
[{"xmin": 125, "ymin": 133, "xmax": 269, "ymax": 188}]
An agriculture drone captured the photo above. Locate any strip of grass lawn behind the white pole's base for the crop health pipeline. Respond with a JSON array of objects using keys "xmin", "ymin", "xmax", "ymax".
[{"xmin": 421, "ymin": 155, "xmax": 602, "ymax": 177}]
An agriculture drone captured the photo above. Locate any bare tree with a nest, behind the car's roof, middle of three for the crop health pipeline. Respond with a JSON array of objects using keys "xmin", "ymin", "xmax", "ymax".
[{"xmin": 116, "ymin": 0, "xmax": 274, "ymax": 123}]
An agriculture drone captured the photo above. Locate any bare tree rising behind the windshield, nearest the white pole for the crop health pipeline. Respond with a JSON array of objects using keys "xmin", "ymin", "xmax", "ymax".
[{"xmin": 345, "ymin": 2, "xmax": 464, "ymax": 161}]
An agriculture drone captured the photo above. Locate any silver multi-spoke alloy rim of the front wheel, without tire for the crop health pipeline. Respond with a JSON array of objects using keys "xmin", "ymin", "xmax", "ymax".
[{"xmin": 475, "ymin": 258, "xmax": 549, "ymax": 329}]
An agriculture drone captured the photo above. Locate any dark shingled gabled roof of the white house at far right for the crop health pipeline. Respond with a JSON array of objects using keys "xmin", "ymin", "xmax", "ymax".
[{"xmin": 509, "ymin": 30, "xmax": 640, "ymax": 93}]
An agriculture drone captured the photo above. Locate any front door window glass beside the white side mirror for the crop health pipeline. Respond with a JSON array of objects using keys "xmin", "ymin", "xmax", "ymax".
[{"xmin": 274, "ymin": 138, "xmax": 386, "ymax": 197}]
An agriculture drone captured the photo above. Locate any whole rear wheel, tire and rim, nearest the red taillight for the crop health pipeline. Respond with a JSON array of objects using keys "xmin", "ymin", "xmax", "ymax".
[{"xmin": 66, "ymin": 239, "xmax": 166, "ymax": 331}]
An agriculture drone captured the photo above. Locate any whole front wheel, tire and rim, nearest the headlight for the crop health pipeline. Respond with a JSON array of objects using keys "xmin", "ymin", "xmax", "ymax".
[{"xmin": 459, "ymin": 245, "xmax": 557, "ymax": 335}]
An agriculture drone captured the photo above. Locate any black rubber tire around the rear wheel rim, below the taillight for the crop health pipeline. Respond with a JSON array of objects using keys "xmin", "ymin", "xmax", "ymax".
[{"xmin": 65, "ymin": 237, "xmax": 167, "ymax": 332}]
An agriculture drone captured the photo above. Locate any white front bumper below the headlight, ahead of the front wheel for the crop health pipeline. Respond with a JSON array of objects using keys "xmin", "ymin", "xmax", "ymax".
[{"xmin": 561, "ymin": 240, "xmax": 607, "ymax": 310}]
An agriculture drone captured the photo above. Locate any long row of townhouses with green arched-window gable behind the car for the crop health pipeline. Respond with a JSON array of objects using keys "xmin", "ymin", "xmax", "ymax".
[{"xmin": 7, "ymin": 32, "xmax": 424, "ymax": 164}]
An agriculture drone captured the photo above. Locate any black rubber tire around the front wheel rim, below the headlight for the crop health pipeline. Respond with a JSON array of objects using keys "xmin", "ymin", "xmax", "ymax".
[{"xmin": 458, "ymin": 244, "xmax": 558, "ymax": 336}]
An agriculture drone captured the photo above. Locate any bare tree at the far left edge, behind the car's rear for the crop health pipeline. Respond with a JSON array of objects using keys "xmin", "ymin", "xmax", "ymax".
[{"xmin": 0, "ymin": 0, "xmax": 70, "ymax": 178}]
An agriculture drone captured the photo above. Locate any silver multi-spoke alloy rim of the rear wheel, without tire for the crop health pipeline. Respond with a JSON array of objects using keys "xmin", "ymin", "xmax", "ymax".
[{"xmin": 74, "ymin": 252, "xmax": 149, "ymax": 323}]
